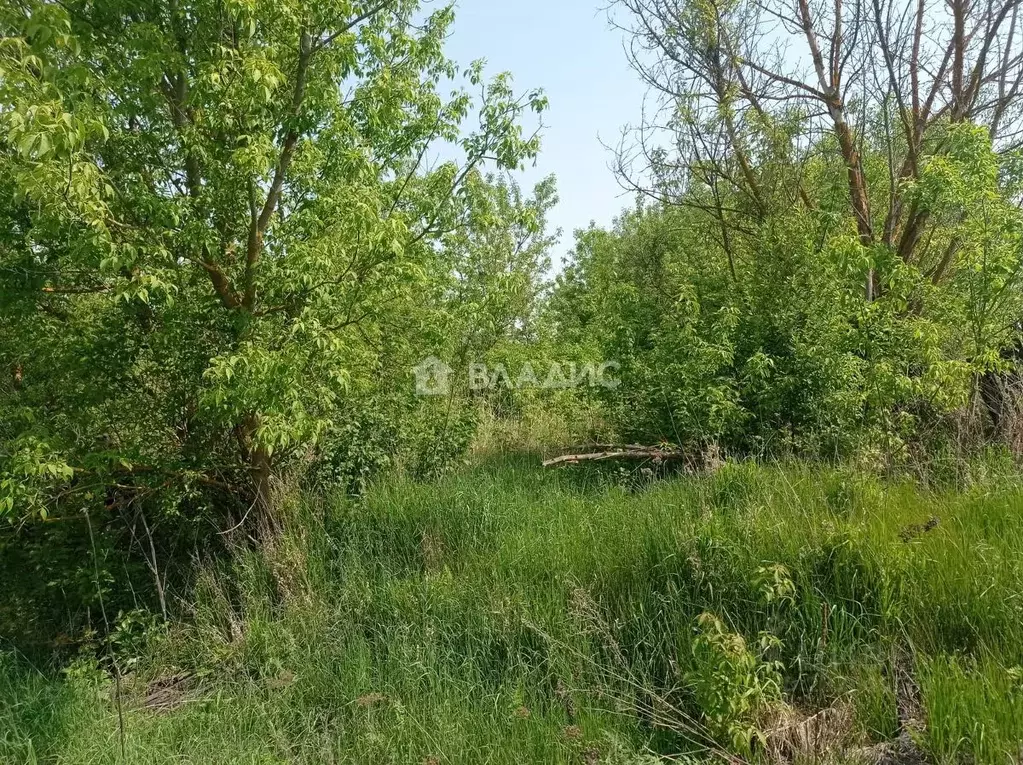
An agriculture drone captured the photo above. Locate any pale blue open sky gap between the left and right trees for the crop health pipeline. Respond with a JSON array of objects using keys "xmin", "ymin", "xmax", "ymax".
[{"xmin": 441, "ymin": 0, "xmax": 646, "ymax": 267}]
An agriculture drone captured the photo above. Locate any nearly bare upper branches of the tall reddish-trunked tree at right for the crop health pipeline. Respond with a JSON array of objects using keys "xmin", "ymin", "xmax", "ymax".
[{"xmin": 616, "ymin": 0, "xmax": 1023, "ymax": 286}]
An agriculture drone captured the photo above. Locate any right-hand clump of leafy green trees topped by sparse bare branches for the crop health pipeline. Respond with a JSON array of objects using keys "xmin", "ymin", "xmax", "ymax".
[{"xmin": 553, "ymin": 0, "xmax": 1023, "ymax": 460}]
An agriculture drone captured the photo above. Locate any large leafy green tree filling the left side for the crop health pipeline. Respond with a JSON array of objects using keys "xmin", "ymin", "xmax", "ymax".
[{"xmin": 0, "ymin": 0, "xmax": 545, "ymax": 531}]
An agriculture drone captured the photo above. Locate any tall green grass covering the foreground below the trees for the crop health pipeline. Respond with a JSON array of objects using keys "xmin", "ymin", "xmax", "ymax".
[{"xmin": 0, "ymin": 457, "xmax": 1023, "ymax": 764}]
